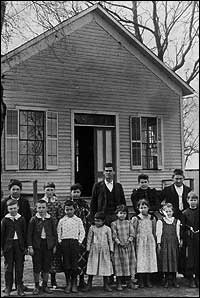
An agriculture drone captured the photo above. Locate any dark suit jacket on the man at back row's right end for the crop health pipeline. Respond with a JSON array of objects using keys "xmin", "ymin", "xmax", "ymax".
[{"xmin": 160, "ymin": 184, "xmax": 191, "ymax": 220}]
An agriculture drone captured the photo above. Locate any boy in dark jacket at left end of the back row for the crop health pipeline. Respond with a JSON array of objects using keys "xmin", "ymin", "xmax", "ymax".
[{"xmin": 1, "ymin": 179, "xmax": 32, "ymax": 291}]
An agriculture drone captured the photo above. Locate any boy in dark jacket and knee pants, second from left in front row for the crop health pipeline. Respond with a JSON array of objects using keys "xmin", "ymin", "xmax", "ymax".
[{"xmin": 27, "ymin": 200, "xmax": 57, "ymax": 295}]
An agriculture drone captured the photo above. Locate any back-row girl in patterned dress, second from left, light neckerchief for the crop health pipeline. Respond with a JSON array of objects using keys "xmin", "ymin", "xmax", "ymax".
[{"xmin": 39, "ymin": 182, "xmax": 64, "ymax": 289}]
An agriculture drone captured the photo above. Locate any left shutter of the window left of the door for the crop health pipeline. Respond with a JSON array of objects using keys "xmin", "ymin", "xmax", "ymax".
[{"xmin": 5, "ymin": 110, "xmax": 19, "ymax": 170}]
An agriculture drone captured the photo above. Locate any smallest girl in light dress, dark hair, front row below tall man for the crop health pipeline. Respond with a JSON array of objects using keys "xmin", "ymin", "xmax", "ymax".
[{"xmin": 85, "ymin": 212, "xmax": 113, "ymax": 292}]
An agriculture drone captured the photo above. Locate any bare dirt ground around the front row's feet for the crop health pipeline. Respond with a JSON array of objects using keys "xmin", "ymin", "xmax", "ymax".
[{"xmin": 1, "ymin": 256, "xmax": 199, "ymax": 297}]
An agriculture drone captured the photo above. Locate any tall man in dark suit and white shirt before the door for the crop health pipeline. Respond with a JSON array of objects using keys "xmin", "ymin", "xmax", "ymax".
[{"xmin": 90, "ymin": 163, "xmax": 126, "ymax": 226}]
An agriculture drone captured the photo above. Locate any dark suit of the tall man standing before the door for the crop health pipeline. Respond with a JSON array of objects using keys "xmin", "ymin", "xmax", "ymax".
[{"xmin": 90, "ymin": 181, "xmax": 126, "ymax": 225}]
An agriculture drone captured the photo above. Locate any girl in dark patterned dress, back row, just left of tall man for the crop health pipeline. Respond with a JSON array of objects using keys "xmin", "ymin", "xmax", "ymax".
[{"xmin": 70, "ymin": 183, "xmax": 90, "ymax": 289}]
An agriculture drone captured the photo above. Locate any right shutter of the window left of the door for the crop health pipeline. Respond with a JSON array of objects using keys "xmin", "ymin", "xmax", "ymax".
[{"xmin": 46, "ymin": 112, "xmax": 58, "ymax": 170}]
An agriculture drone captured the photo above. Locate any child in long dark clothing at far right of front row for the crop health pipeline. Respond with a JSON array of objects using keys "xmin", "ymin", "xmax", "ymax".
[{"xmin": 182, "ymin": 191, "xmax": 199, "ymax": 288}]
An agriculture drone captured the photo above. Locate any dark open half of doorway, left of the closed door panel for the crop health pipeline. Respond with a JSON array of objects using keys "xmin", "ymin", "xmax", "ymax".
[{"xmin": 75, "ymin": 126, "xmax": 95, "ymax": 197}]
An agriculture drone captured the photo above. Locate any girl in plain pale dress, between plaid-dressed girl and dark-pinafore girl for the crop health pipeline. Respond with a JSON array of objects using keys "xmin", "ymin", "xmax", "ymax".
[{"xmin": 131, "ymin": 199, "xmax": 158, "ymax": 288}]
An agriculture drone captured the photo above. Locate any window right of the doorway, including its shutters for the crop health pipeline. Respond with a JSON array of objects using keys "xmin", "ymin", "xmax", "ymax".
[{"xmin": 130, "ymin": 116, "xmax": 162, "ymax": 169}]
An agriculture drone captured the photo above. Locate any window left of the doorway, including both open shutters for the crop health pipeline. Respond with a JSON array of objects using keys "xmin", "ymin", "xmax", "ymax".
[{"xmin": 5, "ymin": 110, "xmax": 57, "ymax": 170}]
